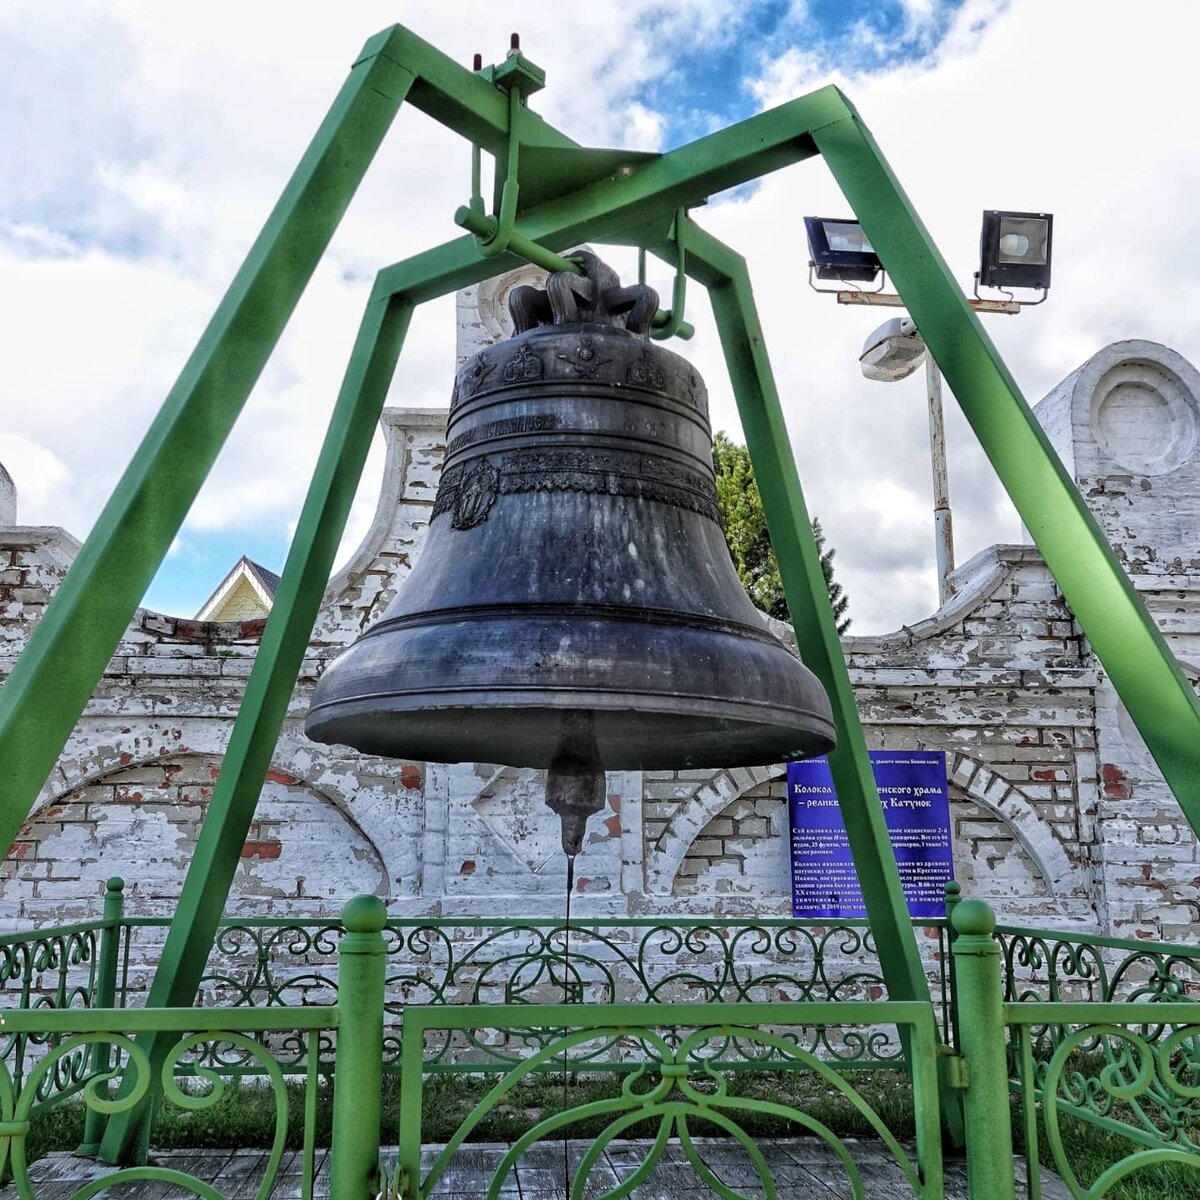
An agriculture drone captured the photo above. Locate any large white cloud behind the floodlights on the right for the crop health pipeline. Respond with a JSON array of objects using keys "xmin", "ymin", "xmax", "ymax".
[{"xmin": 697, "ymin": 2, "xmax": 1200, "ymax": 632}]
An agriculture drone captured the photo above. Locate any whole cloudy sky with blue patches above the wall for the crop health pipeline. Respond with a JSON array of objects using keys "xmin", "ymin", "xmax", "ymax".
[{"xmin": 0, "ymin": 0, "xmax": 1200, "ymax": 634}]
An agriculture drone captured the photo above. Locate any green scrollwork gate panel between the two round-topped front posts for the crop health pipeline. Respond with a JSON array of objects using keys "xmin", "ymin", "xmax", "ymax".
[{"xmin": 397, "ymin": 1001, "xmax": 942, "ymax": 1200}]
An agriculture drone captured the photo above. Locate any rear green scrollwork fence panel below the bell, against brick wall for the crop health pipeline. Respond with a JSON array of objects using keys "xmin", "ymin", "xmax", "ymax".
[{"xmin": 187, "ymin": 919, "xmax": 916, "ymax": 1074}]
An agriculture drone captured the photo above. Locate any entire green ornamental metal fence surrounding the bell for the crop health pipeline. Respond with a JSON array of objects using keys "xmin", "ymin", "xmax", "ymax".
[{"xmin": 0, "ymin": 880, "xmax": 1200, "ymax": 1200}]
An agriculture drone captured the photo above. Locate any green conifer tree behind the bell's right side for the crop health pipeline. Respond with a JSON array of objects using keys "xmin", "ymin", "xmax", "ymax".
[{"xmin": 713, "ymin": 433, "xmax": 850, "ymax": 634}]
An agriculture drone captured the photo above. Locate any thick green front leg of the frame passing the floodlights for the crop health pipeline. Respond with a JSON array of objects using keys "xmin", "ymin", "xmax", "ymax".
[{"xmin": 814, "ymin": 98, "xmax": 1200, "ymax": 836}]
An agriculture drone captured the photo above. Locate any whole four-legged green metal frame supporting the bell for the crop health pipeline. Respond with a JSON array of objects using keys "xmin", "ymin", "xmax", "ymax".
[{"xmin": 0, "ymin": 16, "xmax": 1200, "ymax": 1158}]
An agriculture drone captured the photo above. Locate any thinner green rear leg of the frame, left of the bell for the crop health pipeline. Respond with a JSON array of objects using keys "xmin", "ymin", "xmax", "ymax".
[{"xmin": 100, "ymin": 288, "xmax": 413, "ymax": 1163}]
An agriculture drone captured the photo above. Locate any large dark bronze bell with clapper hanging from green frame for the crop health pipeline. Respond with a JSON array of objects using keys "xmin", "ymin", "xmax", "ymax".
[{"xmin": 306, "ymin": 253, "xmax": 834, "ymax": 854}]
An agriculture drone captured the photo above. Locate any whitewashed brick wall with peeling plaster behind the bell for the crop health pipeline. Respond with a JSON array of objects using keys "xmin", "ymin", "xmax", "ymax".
[{"xmin": 0, "ymin": 298, "xmax": 1200, "ymax": 937}]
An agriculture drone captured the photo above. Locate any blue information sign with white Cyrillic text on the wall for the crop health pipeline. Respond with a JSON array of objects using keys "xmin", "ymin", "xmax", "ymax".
[{"xmin": 787, "ymin": 750, "xmax": 954, "ymax": 917}]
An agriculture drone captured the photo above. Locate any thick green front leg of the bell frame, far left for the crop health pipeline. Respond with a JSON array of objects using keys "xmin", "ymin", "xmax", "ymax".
[{"xmin": 0, "ymin": 35, "xmax": 413, "ymax": 848}]
